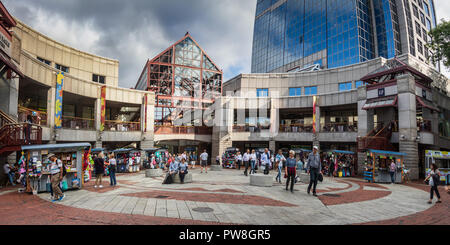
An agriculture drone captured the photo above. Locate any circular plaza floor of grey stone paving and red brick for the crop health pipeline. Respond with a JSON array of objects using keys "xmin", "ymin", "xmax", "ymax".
[{"xmin": 0, "ymin": 169, "xmax": 450, "ymax": 225}]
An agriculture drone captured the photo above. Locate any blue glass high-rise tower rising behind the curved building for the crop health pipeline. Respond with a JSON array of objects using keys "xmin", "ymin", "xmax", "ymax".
[{"xmin": 251, "ymin": 0, "xmax": 439, "ymax": 73}]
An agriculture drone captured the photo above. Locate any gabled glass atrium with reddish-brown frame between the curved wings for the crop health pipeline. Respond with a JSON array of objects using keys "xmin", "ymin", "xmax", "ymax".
[{"xmin": 136, "ymin": 33, "xmax": 222, "ymax": 154}]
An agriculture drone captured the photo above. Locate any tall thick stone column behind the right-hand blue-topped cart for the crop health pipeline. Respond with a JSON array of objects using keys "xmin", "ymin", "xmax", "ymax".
[{"xmin": 397, "ymin": 74, "xmax": 419, "ymax": 179}]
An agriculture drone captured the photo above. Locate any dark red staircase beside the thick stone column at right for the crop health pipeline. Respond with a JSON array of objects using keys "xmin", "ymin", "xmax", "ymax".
[{"xmin": 358, "ymin": 122, "xmax": 395, "ymax": 152}]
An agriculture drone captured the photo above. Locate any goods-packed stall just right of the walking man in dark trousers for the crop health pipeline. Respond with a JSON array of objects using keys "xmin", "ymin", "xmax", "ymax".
[{"xmin": 328, "ymin": 150, "xmax": 356, "ymax": 178}]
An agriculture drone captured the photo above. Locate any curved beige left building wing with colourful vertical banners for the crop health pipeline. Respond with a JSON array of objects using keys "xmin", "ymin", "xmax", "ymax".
[{"xmin": 0, "ymin": 13, "xmax": 155, "ymax": 182}]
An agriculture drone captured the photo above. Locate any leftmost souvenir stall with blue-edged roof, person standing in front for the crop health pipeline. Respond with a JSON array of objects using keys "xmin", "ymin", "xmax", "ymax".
[{"xmin": 22, "ymin": 143, "xmax": 91, "ymax": 194}]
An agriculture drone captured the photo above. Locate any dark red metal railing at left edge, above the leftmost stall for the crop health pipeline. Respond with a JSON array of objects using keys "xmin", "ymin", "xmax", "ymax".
[{"xmin": 0, "ymin": 123, "xmax": 42, "ymax": 146}]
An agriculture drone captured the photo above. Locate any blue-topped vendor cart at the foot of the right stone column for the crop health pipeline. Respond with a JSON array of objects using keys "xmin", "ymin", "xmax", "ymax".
[{"xmin": 364, "ymin": 149, "xmax": 406, "ymax": 183}]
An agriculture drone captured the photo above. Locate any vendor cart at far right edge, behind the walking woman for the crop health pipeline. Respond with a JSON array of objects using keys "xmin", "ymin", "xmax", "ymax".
[{"xmin": 425, "ymin": 150, "xmax": 450, "ymax": 185}]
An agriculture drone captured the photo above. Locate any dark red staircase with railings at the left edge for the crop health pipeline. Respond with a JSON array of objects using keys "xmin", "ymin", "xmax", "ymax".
[{"xmin": 0, "ymin": 110, "xmax": 42, "ymax": 156}]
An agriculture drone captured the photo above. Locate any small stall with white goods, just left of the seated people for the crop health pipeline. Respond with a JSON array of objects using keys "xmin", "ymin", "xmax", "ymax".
[{"xmin": 113, "ymin": 149, "xmax": 141, "ymax": 173}]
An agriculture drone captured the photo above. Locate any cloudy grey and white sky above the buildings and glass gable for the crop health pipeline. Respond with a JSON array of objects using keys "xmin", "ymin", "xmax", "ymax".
[{"xmin": 2, "ymin": 0, "xmax": 450, "ymax": 88}]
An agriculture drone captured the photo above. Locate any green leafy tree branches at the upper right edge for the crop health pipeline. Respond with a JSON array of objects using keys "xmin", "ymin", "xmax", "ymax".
[{"xmin": 427, "ymin": 19, "xmax": 450, "ymax": 68}]
